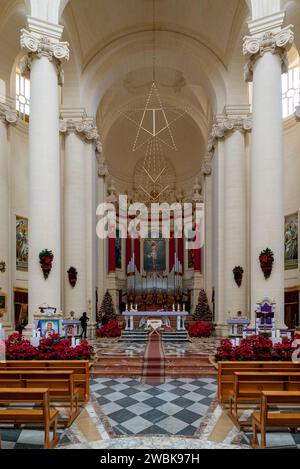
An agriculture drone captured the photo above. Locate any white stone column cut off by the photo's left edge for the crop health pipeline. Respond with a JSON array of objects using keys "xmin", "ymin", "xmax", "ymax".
[{"xmin": 0, "ymin": 99, "xmax": 17, "ymax": 329}]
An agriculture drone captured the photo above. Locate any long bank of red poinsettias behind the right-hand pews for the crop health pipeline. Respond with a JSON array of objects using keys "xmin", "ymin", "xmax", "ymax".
[{"xmin": 215, "ymin": 335, "xmax": 300, "ymax": 361}]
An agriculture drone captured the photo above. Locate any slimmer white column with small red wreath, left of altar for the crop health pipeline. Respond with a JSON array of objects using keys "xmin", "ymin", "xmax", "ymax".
[{"xmin": 60, "ymin": 109, "xmax": 87, "ymax": 317}]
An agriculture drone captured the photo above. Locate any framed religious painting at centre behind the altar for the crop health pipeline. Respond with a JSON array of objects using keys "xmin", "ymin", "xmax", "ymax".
[{"xmin": 144, "ymin": 239, "xmax": 166, "ymax": 273}]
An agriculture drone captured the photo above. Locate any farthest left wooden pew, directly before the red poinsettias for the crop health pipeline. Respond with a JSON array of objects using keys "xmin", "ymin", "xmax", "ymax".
[{"xmin": 0, "ymin": 360, "xmax": 90, "ymax": 402}]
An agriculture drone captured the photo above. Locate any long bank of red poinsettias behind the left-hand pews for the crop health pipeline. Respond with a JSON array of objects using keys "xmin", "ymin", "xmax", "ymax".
[{"xmin": 5, "ymin": 333, "xmax": 94, "ymax": 360}]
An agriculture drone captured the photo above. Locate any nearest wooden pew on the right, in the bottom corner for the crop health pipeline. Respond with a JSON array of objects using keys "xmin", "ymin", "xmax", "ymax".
[{"xmin": 251, "ymin": 391, "xmax": 300, "ymax": 449}]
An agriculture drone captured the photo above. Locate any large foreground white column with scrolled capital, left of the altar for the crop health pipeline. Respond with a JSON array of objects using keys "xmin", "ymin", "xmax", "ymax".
[{"xmin": 21, "ymin": 18, "xmax": 69, "ymax": 327}]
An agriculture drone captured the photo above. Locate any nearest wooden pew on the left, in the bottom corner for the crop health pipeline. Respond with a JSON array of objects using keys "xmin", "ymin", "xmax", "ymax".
[{"xmin": 0, "ymin": 388, "xmax": 59, "ymax": 448}]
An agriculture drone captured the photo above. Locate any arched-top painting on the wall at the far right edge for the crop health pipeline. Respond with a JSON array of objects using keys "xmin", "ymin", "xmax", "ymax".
[{"xmin": 284, "ymin": 213, "xmax": 298, "ymax": 270}]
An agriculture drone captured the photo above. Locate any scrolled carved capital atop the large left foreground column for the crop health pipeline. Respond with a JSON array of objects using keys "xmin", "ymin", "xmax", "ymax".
[{"xmin": 20, "ymin": 29, "xmax": 70, "ymax": 85}]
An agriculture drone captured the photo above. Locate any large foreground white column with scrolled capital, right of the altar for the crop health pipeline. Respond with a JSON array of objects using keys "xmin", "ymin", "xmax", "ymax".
[{"xmin": 243, "ymin": 13, "xmax": 294, "ymax": 326}]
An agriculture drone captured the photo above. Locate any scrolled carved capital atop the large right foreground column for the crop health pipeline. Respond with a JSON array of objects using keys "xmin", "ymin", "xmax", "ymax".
[{"xmin": 243, "ymin": 25, "xmax": 294, "ymax": 81}]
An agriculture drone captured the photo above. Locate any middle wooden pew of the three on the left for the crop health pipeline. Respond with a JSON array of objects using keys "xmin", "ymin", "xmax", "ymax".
[{"xmin": 0, "ymin": 369, "xmax": 79, "ymax": 426}]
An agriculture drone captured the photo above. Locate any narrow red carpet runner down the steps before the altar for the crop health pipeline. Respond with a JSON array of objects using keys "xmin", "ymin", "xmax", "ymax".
[{"xmin": 142, "ymin": 334, "xmax": 165, "ymax": 384}]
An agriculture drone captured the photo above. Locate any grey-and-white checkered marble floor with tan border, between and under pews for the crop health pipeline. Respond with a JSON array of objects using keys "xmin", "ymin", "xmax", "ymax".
[{"xmin": 0, "ymin": 378, "xmax": 300, "ymax": 449}]
